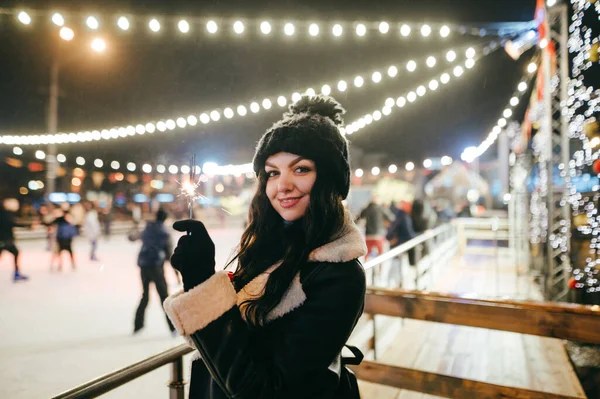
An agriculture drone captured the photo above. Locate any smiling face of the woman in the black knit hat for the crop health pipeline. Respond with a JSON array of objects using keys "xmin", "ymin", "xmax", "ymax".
[{"xmin": 265, "ymin": 152, "xmax": 317, "ymax": 222}]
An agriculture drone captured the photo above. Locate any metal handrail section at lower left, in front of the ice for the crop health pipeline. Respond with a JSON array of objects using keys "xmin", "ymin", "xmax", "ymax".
[{"xmin": 52, "ymin": 344, "xmax": 194, "ymax": 399}]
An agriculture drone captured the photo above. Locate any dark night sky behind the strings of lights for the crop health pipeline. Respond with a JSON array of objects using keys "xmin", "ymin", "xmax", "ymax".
[{"xmin": 0, "ymin": 0, "xmax": 535, "ymax": 167}]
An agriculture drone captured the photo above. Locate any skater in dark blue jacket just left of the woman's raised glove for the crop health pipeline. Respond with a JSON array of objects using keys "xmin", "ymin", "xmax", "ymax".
[{"xmin": 130, "ymin": 209, "xmax": 175, "ymax": 335}]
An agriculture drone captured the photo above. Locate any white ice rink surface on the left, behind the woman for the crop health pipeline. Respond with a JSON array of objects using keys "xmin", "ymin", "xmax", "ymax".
[{"xmin": 0, "ymin": 223, "xmax": 242, "ymax": 399}]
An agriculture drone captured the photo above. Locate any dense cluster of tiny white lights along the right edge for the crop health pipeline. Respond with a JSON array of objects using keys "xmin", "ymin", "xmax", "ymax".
[{"xmin": 567, "ymin": 0, "xmax": 600, "ymax": 293}]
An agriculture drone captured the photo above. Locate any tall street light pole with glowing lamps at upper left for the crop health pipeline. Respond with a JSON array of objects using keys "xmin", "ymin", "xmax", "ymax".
[{"xmin": 46, "ymin": 27, "xmax": 106, "ymax": 196}]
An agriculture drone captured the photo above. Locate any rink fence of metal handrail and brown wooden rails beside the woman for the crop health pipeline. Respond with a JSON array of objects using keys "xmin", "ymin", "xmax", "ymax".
[{"xmin": 53, "ymin": 225, "xmax": 600, "ymax": 399}]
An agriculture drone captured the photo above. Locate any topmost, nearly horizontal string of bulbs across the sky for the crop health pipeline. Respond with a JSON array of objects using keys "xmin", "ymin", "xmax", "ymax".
[{"xmin": 0, "ymin": 9, "xmax": 534, "ymax": 38}]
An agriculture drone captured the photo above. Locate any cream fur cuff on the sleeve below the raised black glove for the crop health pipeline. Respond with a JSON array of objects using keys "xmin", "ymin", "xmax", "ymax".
[{"xmin": 163, "ymin": 271, "xmax": 237, "ymax": 336}]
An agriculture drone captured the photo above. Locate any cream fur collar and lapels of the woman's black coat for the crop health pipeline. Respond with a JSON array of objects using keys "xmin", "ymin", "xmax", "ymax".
[{"xmin": 237, "ymin": 220, "xmax": 367, "ymax": 322}]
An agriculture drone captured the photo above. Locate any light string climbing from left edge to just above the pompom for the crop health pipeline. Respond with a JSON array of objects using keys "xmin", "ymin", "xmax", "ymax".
[{"xmin": 0, "ymin": 46, "xmax": 475, "ymax": 145}]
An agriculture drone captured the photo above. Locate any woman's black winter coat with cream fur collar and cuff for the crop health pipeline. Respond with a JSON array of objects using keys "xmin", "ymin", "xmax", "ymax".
[{"xmin": 164, "ymin": 224, "xmax": 366, "ymax": 399}]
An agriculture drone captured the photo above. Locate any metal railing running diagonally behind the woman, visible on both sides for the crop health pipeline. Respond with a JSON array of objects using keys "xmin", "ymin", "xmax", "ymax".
[{"xmin": 52, "ymin": 224, "xmax": 456, "ymax": 399}]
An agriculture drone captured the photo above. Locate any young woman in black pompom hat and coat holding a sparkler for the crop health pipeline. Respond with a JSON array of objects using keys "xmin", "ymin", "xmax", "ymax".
[{"xmin": 164, "ymin": 96, "xmax": 366, "ymax": 399}]
